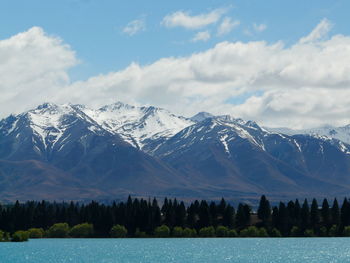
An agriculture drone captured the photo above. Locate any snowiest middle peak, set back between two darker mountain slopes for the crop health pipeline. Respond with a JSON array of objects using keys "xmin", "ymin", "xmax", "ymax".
[{"xmin": 82, "ymin": 102, "xmax": 194, "ymax": 152}]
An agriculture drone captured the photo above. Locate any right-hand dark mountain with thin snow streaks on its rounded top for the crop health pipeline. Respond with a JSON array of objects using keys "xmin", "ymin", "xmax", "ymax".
[{"xmin": 155, "ymin": 116, "xmax": 350, "ymax": 199}]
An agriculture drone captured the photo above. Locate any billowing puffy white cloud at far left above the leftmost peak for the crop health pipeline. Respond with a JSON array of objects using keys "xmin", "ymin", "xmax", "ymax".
[{"xmin": 0, "ymin": 27, "xmax": 78, "ymax": 116}]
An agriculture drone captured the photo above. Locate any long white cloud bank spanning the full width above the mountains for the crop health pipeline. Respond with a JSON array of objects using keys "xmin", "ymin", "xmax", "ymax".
[{"xmin": 0, "ymin": 19, "xmax": 350, "ymax": 130}]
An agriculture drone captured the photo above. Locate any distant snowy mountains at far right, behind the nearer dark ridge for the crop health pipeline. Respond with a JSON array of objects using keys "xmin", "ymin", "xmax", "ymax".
[{"xmin": 267, "ymin": 124, "xmax": 350, "ymax": 144}]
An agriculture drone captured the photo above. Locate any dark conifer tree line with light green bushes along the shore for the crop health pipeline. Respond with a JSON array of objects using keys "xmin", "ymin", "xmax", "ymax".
[{"xmin": 0, "ymin": 196, "xmax": 350, "ymax": 241}]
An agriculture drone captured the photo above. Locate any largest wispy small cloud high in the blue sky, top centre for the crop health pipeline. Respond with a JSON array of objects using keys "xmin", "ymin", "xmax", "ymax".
[{"xmin": 162, "ymin": 8, "xmax": 227, "ymax": 29}]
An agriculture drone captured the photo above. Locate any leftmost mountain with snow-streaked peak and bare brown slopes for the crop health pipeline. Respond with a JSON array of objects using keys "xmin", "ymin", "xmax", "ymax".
[{"xmin": 0, "ymin": 104, "xmax": 191, "ymax": 200}]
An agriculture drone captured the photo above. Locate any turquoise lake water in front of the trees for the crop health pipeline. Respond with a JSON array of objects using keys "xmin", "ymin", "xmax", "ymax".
[{"xmin": 0, "ymin": 238, "xmax": 350, "ymax": 263}]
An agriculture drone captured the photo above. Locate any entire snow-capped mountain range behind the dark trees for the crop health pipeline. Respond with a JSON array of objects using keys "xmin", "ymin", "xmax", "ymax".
[{"xmin": 0, "ymin": 102, "xmax": 350, "ymax": 201}]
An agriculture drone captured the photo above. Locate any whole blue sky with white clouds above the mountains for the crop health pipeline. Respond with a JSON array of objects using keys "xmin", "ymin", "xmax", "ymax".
[{"xmin": 0, "ymin": 0, "xmax": 350, "ymax": 129}]
